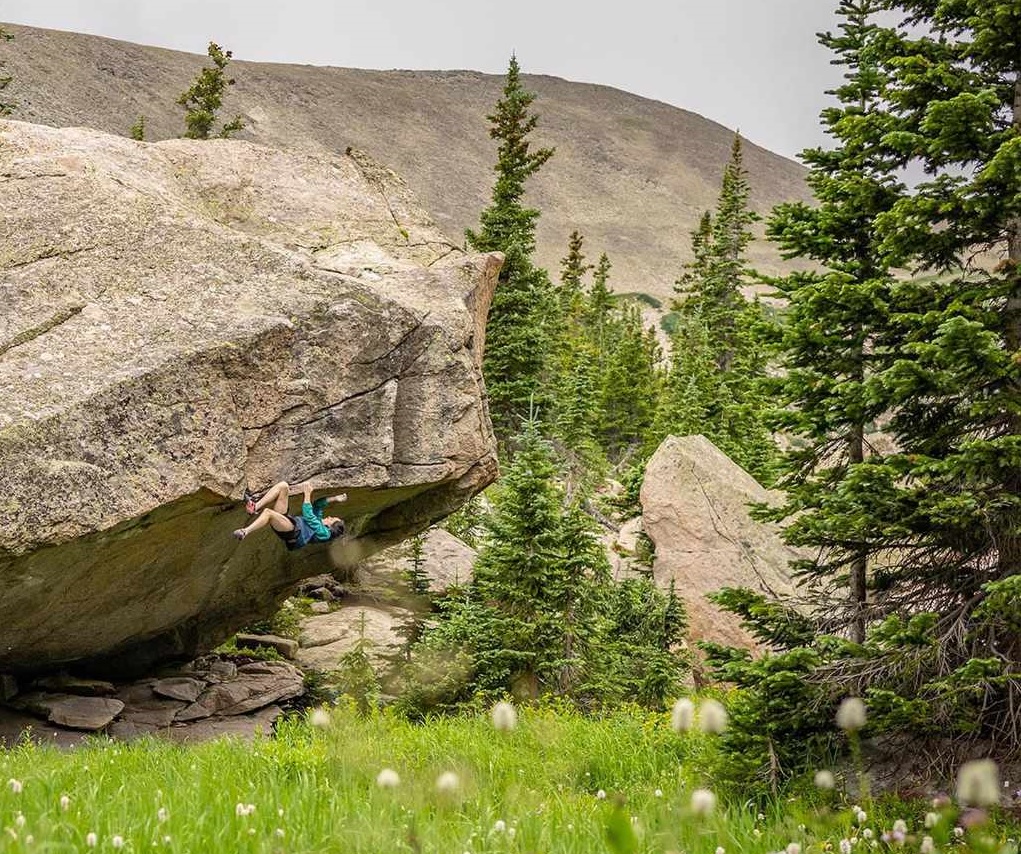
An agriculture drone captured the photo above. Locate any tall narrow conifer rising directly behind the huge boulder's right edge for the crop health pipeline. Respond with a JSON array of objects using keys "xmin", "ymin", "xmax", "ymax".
[{"xmin": 466, "ymin": 56, "xmax": 553, "ymax": 436}]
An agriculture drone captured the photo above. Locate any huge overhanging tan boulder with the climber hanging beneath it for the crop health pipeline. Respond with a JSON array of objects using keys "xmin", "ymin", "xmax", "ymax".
[{"xmin": 0, "ymin": 122, "xmax": 500, "ymax": 677}]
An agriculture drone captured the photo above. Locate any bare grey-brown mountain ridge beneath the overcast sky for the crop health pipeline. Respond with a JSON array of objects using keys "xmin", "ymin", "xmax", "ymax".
[{"xmin": 2, "ymin": 25, "xmax": 808, "ymax": 298}]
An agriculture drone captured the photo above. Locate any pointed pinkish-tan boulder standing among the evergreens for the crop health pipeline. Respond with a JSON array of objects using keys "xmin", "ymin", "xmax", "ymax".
[{"xmin": 641, "ymin": 436, "xmax": 798, "ymax": 649}]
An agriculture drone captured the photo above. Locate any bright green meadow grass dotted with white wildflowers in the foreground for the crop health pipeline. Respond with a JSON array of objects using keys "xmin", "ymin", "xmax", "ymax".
[{"xmin": 0, "ymin": 707, "xmax": 1006, "ymax": 854}]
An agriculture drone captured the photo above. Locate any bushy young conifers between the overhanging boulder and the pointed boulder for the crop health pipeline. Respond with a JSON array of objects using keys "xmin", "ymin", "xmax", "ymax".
[{"xmin": 402, "ymin": 421, "xmax": 683, "ymax": 714}]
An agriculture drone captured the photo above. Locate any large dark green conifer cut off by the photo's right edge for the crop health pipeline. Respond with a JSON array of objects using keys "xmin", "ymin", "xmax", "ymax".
[{"xmin": 849, "ymin": 0, "xmax": 1021, "ymax": 751}]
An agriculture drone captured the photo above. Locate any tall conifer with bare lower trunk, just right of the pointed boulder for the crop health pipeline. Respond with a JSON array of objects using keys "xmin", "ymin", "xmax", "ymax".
[{"xmin": 768, "ymin": 0, "xmax": 903, "ymax": 643}]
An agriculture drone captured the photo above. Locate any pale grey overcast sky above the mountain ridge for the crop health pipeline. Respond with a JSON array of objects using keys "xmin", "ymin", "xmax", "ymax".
[{"xmin": 0, "ymin": 0, "xmax": 839, "ymax": 155}]
